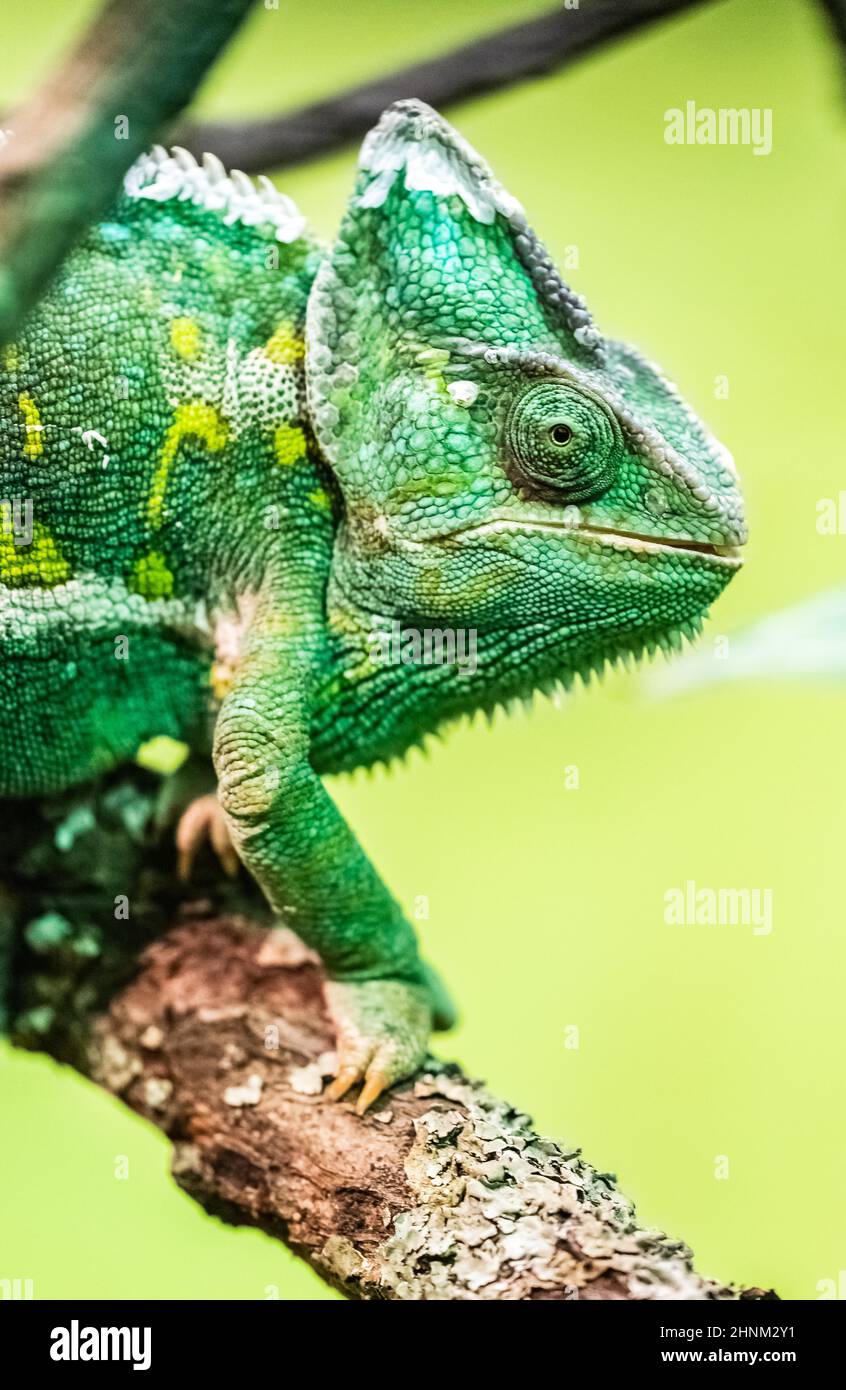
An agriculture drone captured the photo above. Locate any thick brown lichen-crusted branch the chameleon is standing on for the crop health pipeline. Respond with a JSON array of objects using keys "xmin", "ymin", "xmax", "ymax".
[{"xmin": 0, "ymin": 769, "xmax": 775, "ymax": 1301}]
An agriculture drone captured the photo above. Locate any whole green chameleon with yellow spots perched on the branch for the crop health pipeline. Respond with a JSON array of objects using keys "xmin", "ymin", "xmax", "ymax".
[{"xmin": 0, "ymin": 100, "xmax": 745, "ymax": 1111}]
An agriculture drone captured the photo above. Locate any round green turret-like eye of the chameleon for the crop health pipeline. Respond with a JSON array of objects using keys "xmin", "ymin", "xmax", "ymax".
[{"xmin": 506, "ymin": 381, "xmax": 621, "ymax": 502}]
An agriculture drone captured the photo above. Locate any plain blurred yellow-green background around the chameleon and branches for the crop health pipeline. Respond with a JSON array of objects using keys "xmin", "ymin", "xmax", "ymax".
[{"xmin": 0, "ymin": 0, "xmax": 846, "ymax": 1298}]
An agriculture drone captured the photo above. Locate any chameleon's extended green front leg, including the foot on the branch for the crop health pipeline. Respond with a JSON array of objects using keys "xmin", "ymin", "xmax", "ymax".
[{"xmin": 214, "ymin": 594, "xmax": 432, "ymax": 1113}]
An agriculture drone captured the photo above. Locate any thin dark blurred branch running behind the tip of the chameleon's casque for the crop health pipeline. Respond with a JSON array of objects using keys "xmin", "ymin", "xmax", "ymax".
[{"xmin": 174, "ymin": 0, "xmax": 704, "ymax": 174}]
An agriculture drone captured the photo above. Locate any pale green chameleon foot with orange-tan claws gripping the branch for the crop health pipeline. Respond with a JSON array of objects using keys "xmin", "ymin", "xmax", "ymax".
[{"xmin": 325, "ymin": 980, "xmax": 432, "ymax": 1115}]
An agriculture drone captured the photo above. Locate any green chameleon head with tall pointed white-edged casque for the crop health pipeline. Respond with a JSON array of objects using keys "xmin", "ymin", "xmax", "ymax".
[{"xmin": 307, "ymin": 101, "xmax": 746, "ymax": 685}]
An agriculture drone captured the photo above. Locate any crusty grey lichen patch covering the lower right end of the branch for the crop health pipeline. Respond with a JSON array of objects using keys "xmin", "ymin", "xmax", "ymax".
[{"xmin": 368, "ymin": 1072, "xmax": 738, "ymax": 1300}]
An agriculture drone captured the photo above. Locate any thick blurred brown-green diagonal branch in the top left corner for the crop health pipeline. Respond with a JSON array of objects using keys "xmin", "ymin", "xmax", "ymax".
[{"xmin": 0, "ymin": 0, "xmax": 250, "ymax": 342}]
